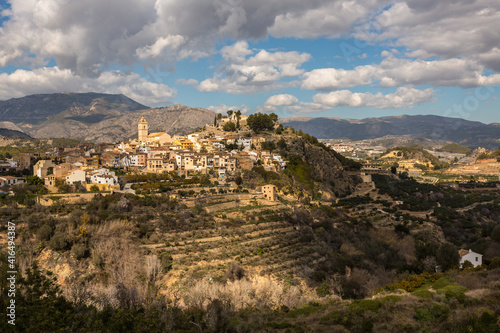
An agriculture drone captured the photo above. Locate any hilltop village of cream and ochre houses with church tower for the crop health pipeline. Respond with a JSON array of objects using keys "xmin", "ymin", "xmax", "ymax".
[{"xmin": 0, "ymin": 111, "xmax": 286, "ymax": 192}]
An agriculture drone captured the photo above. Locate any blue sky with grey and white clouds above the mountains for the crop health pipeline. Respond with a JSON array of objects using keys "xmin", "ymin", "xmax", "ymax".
[{"xmin": 0, "ymin": 0, "xmax": 500, "ymax": 123}]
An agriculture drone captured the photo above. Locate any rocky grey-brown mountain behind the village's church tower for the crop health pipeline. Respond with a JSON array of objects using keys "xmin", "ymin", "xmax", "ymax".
[{"xmin": 0, "ymin": 93, "xmax": 214, "ymax": 142}]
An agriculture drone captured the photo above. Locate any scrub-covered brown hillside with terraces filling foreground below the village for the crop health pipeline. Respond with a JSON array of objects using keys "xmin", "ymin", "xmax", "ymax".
[{"xmin": 0, "ymin": 154, "xmax": 500, "ymax": 332}]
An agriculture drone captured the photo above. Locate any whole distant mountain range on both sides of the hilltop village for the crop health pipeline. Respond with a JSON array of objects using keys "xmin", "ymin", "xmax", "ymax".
[{"xmin": 0, "ymin": 93, "xmax": 500, "ymax": 148}]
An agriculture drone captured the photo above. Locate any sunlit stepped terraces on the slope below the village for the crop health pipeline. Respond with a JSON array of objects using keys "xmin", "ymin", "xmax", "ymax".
[{"xmin": 139, "ymin": 196, "xmax": 328, "ymax": 285}]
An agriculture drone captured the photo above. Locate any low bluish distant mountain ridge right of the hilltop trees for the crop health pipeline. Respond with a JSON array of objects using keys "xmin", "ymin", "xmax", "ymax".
[{"xmin": 280, "ymin": 115, "xmax": 500, "ymax": 148}]
